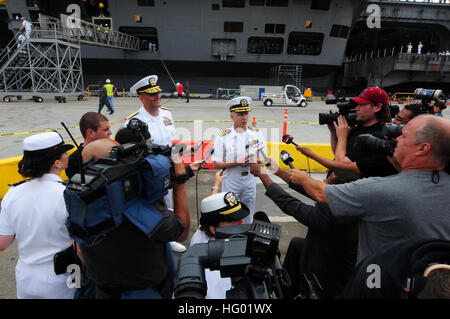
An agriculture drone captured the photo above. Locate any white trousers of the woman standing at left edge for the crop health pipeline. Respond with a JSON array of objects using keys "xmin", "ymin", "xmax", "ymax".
[{"xmin": 16, "ymin": 259, "xmax": 76, "ymax": 299}]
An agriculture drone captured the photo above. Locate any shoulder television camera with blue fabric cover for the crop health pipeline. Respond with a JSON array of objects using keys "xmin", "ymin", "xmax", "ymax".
[{"xmin": 64, "ymin": 119, "xmax": 181, "ymax": 243}]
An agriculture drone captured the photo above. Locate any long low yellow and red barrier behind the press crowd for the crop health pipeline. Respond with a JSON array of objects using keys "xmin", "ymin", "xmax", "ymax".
[{"xmin": 0, "ymin": 140, "xmax": 334, "ymax": 198}]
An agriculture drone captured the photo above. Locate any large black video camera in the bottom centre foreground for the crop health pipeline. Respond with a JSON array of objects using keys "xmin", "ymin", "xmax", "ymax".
[{"xmin": 174, "ymin": 220, "xmax": 282, "ymax": 299}]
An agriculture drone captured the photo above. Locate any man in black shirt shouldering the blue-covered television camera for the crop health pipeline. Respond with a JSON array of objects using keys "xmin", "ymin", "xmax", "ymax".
[{"xmin": 74, "ymin": 139, "xmax": 190, "ymax": 299}]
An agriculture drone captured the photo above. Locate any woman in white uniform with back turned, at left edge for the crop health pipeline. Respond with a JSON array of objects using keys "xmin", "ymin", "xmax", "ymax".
[{"xmin": 0, "ymin": 132, "xmax": 76, "ymax": 299}]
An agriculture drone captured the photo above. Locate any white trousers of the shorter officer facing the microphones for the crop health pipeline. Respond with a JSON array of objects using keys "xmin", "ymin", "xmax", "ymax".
[{"xmin": 222, "ymin": 171, "xmax": 256, "ymax": 224}]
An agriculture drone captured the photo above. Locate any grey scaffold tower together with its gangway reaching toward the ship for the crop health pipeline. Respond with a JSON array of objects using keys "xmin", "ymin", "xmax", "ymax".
[{"xmin": 0, "ymin": 15, "xmax": 139, "ymax": 103}]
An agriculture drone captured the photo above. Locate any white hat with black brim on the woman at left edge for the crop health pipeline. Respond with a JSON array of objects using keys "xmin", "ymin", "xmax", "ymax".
[{"xmin": 23, "ymin": 132, "xmax": 73, "ymax": 157}]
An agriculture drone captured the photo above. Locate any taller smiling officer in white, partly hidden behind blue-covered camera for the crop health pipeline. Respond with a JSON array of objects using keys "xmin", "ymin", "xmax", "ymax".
[{"xmin": 125, "ymin": 75, "xmax": 186, "ymax": 252}]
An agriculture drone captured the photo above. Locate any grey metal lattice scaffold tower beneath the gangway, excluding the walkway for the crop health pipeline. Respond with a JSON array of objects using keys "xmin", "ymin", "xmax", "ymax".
[{"xmin": 0, "ymin": 31, "xmax": 84, "ymax": 102}]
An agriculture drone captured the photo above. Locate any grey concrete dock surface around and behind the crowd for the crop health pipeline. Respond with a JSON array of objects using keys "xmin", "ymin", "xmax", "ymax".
[{"xmin": 0, "ymin": 97, "xmax": 336, "ymax": 299}]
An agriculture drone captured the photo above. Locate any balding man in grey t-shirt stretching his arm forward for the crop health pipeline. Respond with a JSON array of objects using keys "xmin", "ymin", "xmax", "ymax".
[{"xmin": 290, "ymin": 115, "xmax": 450, "ymax": 262}]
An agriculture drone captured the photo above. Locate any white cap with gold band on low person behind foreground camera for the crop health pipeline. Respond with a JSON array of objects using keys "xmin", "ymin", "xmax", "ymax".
[{"xmin": 200, "ymin": 192, "xmax": 250, "ymax": 226}]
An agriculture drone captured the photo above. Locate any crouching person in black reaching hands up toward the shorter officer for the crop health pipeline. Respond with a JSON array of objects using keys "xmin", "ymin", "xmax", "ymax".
[{"xmin": 251, "ymin": 160, "xmax": 359, "ymax": 298}]
